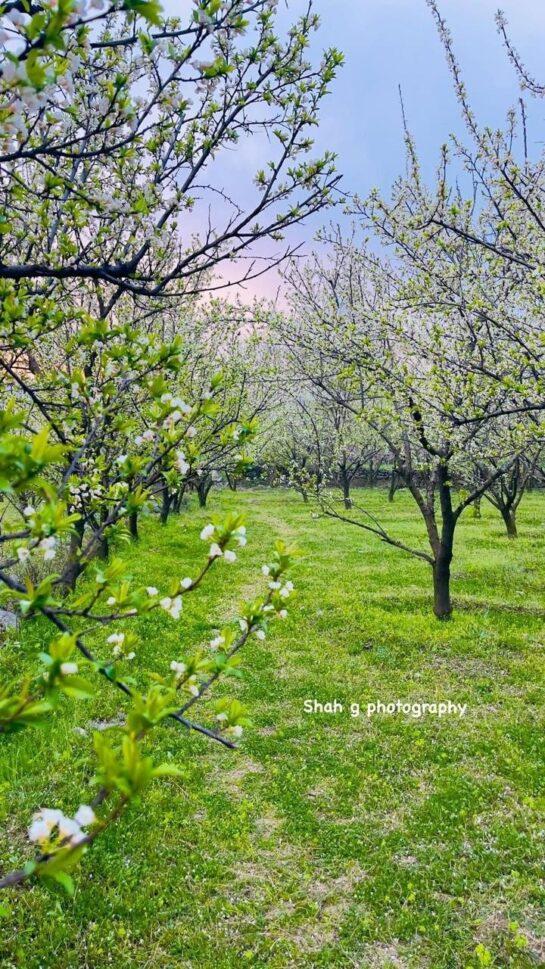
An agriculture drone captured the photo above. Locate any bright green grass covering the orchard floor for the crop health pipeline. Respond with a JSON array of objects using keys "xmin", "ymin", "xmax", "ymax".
[{"xmin": 0, "ymin": 490, "xmax": 545, "ymax": 969}]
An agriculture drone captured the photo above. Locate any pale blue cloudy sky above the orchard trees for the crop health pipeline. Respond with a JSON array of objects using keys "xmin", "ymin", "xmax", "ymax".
[{"xmin": 171, "ymin": 0, "xmax": 545, "ymax": 299}]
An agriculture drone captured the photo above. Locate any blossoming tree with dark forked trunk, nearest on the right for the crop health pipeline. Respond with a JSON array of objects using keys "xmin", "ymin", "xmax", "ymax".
[{"xmin": 283, "ymin": 235, "xmax": 525, "ymax": 619}]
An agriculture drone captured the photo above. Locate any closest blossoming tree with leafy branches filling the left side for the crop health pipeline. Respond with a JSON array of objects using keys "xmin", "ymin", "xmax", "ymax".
[{"xmin": 0, "ymin": 0, "xmax": 341, "ymax": 891}]
